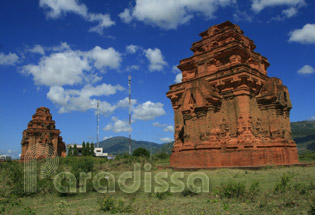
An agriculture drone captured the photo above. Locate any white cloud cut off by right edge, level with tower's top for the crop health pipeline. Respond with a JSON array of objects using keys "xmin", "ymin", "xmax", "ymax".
[{"xmin": 289, "ymin": 24, "xmax": 315, "ymax": 44}]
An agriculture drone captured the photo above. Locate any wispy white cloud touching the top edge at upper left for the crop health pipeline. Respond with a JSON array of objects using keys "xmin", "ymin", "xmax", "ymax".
[{"xmin": 39, "ymin": 0, "xmax": 115, "ymax": 34}]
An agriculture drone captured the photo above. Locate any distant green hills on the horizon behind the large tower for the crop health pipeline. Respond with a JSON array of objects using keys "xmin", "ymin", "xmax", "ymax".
[{"xmin": 100, "ymin": 121, "xmax": 315, "ymax": 154}]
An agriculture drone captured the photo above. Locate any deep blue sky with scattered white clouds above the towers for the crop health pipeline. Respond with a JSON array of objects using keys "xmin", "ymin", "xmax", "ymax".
[{"xmin": 0, "ymin": 0, "xmax": 315, "ymax": 156}]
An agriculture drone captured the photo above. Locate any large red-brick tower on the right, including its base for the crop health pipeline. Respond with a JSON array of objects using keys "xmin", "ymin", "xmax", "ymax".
[{"xmin": 167, "ymin": 21, "xmax": 298, "ymax": 168}]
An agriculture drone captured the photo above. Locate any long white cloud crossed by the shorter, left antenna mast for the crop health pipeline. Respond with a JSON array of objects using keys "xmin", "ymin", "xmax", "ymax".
[{"xmin": 47, "ymin": 84, "xmax": 124, "ymax": 115}]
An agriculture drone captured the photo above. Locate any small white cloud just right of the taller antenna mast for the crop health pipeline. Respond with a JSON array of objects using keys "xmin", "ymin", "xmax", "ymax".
[{"xmin": 132, "ymin": 101, "xmax": 165, "ymax": 120}]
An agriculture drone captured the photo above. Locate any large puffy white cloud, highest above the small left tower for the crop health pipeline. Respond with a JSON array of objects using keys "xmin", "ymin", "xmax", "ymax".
[{"xmin": 22, "ymin": 43, "xmax": 121, "ymax": 86}]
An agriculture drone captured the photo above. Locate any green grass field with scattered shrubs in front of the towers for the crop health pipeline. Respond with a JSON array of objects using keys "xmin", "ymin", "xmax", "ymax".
[{"xmin": 0, "ymin": 157, "xmax": 315, "ymax": 215}]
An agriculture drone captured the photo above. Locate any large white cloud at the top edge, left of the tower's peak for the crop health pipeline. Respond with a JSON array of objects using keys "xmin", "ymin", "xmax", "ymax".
[{"xmin": 119, "ymin": 0, "xmax": 236, "ymax": 29}]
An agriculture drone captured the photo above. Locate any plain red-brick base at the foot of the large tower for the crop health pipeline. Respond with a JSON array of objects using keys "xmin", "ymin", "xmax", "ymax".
[{"xmin": 170, "ymin": 146, "xmax": 299, "ymax": 169}]
